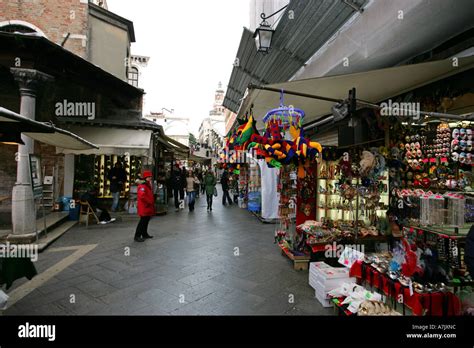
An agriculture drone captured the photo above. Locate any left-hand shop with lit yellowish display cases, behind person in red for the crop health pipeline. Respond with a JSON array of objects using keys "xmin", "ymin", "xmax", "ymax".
[{"xmin": 72, "ymin": 129, "xmax": 188, "ymax": 214}]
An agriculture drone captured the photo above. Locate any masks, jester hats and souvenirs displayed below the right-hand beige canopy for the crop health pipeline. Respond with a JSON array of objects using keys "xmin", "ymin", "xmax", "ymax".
[{"xmin": 231, "ymin": 59, "xmax": 474, "ymax": 316}]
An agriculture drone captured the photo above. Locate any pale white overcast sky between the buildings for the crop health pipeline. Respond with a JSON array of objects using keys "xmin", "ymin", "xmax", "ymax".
[{"xmin": 107, "ymin": 0, "xmax": 249, "ymax": 135}]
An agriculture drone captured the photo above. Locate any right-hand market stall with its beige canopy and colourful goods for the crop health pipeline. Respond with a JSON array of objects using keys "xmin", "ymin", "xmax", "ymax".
[{"xmin": 226, "ymin": 57, "xmax": 474, "ymax": 316}]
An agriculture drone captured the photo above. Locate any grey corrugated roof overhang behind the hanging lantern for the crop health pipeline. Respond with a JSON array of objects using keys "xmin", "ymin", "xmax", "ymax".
[{"xmin": 224, "ymin": 0, "xmax": 367, "ymax": 112}]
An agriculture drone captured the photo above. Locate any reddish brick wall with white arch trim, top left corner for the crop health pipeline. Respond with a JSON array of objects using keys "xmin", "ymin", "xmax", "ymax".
[{"xmin": 0, "ymin": 0, "xmax": 88, "ymax": 59}]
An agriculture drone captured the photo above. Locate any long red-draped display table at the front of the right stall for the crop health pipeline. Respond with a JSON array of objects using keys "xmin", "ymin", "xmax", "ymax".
[{"xmin": 350, "ymin": 261, "xmax": 461, "ymax": 316}]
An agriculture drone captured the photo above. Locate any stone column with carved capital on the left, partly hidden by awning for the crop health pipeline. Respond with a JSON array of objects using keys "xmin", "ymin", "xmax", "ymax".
[{"xmin": 10, "ymin": 68, "xmax": 53, "ymax": 235}]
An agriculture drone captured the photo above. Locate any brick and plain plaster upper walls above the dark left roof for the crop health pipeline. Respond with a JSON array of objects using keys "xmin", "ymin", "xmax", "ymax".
[{"xmin": 0, "ymin": 0, "xmax": 135, "ymax": 81}]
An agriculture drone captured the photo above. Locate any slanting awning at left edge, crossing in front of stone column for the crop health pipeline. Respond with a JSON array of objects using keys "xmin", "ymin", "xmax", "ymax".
[{"xmin": 0, "ymin": 107, "xmax": 98, "ymax": 150}]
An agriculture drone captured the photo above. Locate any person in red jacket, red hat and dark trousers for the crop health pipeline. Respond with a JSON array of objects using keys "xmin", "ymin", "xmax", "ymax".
[{"xmin": 135, "ymin": 170, "xmax": 155, "ymax": 242}]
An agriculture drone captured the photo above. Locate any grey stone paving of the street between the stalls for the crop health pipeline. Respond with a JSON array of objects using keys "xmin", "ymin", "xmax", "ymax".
[{"xmin": 3, "ymin": 189, "xmax": 334, "ymax": 315}]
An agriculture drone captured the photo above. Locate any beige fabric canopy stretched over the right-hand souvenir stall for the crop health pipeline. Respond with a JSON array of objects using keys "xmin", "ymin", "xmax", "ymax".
[{"xmin": 237, "ymin": 56, "xmax": 474, "ymax": 129}]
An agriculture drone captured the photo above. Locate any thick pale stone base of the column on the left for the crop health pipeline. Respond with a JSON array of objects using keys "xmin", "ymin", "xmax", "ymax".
[{"xmin": 12, "ymin": 185, "xmax": 36, "ymax": 235}]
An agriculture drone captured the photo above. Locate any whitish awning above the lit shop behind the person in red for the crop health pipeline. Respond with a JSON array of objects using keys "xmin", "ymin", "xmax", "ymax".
[{"xmin": 57, "ymin": 126, "xmax": 153, "ymax": 156}]
